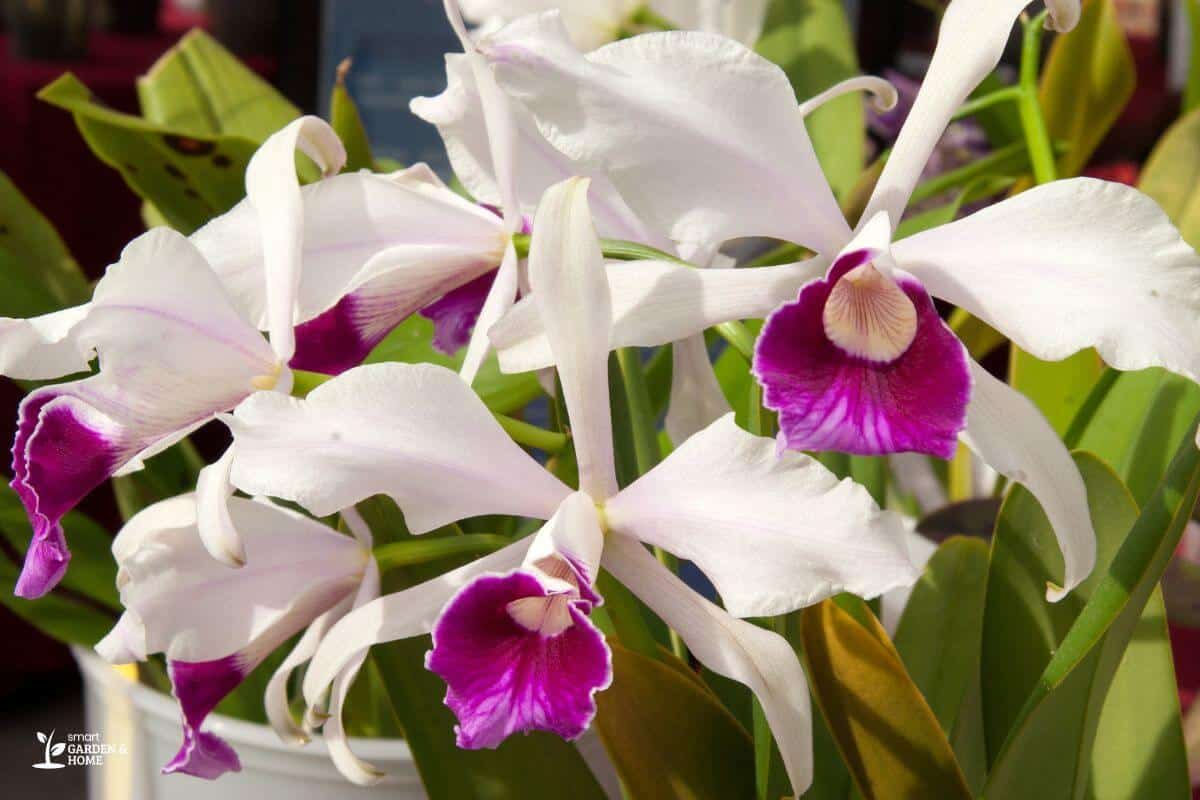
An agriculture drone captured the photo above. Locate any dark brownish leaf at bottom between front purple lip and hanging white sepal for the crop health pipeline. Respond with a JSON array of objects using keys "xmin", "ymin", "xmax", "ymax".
[{"xmin": 595, "ymin": 643, "xmax": 755, "ymax": 800}]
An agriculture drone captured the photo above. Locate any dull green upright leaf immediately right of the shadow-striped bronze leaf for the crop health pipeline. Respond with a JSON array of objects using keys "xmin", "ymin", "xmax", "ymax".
[{"xmin": 895, "ymin": 536, "xmax": 988, "ymax": 789}]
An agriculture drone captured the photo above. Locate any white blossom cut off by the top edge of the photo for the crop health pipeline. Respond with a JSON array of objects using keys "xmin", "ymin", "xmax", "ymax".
[{"xmin": 461, "ymin": 0, "xmax": 767, "ymax": 50}]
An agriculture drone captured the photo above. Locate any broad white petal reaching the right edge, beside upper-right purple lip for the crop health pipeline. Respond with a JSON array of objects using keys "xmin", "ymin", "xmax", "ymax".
[{"xmin": 892, "ymin": 178, "xmax": 1200, "ymax": 379}]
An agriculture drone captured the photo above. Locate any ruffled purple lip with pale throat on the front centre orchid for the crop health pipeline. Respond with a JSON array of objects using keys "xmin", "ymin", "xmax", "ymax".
[{"xmin": 426, "ymin": 570, "xmax": 612, "ymax": 750}]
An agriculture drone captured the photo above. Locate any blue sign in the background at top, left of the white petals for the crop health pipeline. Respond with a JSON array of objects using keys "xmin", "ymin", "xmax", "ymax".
[{"xmin": 317, "ymin": 0, "xmax": 461, "ymax": 175}]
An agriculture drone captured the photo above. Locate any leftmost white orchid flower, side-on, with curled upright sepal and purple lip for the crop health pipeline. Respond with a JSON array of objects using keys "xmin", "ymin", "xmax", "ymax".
[{"xmin": 0, "ymin": 118, "xmax": 344, "ymax": 597}]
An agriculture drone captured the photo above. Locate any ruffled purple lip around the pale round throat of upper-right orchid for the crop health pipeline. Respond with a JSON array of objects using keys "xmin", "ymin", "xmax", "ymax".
[{"xmin": 754, "ymin": 251, "xmax": 971, "ymax": 458}]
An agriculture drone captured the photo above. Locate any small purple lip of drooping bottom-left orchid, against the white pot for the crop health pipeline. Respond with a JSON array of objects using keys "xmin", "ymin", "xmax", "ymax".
[{"xmin": 162, "ymin": 655, "xmax": 247, "ymax": 781}]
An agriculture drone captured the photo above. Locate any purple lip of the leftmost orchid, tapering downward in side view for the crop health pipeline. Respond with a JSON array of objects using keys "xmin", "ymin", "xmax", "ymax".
[{"xmin": 11, "ymin": 389, "xmax": 128, "ymax": 599}]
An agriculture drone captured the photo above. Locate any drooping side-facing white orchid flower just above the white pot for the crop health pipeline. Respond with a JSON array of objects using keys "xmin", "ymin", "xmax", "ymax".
[{"xmin": 96, "ymin": 494, "xmax": 379, "ymax": 780}]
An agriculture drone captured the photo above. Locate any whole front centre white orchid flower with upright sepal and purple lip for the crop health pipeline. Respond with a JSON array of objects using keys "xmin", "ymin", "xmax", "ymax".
[{"xmin": 211, "ymin": 179, "xmax": 916, "ymax": 790}]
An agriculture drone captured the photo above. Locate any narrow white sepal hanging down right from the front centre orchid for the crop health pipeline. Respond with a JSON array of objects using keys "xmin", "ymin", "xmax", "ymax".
[{"xmin": 604, "ymin": 536, "xmax": 812, "ymax": 796}]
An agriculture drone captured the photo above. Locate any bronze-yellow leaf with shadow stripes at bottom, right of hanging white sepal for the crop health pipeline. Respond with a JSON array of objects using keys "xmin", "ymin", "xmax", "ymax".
[{"xmin": 802, "ymin": 597, "xmax": 971, "ymax": 800}]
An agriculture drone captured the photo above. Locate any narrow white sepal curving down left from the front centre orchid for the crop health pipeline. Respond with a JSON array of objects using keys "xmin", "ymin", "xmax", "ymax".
[{"xmin": 304, "ymin": 539, "xmax": 529, "ymax": 708}]
